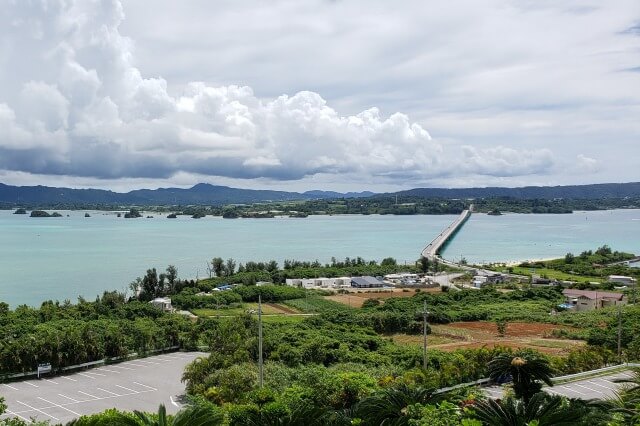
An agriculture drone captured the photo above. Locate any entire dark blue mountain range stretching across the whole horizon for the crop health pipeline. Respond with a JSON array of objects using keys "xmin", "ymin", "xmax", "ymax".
[{"xmin": 0, "ymin": 182, "xmax": 640, "ymax": 205}]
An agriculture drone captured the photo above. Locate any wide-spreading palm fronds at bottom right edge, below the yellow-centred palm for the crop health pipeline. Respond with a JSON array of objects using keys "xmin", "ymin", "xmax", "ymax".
[{"xmin": 473, "ymin": 392, "xmax": 604, "ymax": 426}]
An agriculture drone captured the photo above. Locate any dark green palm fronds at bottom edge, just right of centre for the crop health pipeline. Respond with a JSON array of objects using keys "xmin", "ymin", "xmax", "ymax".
[{"xmin": 355, "ymin": 384, "xmax": 439, "ymax": 426}]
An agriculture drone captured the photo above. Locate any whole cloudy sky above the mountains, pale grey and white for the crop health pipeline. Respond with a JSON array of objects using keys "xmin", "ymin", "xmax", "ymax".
[{"xmin": 0, "ymin": 0, "xmax": 640, "ymax": 191}]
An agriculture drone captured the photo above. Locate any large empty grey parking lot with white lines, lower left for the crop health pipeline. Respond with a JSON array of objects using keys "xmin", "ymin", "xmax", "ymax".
[{"xmin": 0, "ymin": 352, "xmax": 206, "ymax": 424}]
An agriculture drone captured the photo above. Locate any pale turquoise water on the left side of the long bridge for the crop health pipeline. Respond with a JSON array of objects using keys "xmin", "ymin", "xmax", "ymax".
[{"xmin": 0, "ymin": 211, "xmax": 455, "ymax": 306}]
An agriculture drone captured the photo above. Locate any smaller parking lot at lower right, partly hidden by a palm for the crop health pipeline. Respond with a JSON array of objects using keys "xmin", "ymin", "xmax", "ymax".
[{"xmin": 484, "ymin": 371, "xmax": 633, "ymax": 400}]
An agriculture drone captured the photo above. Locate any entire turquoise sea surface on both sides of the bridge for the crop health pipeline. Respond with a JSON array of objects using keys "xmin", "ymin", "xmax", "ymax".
[{"xmin": 0, "ymin": 210, "xmax": 640, "ymax": 307}]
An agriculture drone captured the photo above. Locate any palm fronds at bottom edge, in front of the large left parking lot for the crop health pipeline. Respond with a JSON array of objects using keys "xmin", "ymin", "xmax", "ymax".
[{"xmin": 87, "ymin": 405, "xmax": 223, "ymax": 426}]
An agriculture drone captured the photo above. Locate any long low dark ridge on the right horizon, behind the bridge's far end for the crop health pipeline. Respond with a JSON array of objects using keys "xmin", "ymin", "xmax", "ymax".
[{"xmin": 396, "ymin": 182, "xmax": 640, "ymax": 200}]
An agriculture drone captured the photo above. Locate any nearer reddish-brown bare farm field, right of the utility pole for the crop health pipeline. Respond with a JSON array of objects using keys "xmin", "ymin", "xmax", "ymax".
[{"xmin": 392, "ymin": 321, "xmax": 585, "ymax": 355}]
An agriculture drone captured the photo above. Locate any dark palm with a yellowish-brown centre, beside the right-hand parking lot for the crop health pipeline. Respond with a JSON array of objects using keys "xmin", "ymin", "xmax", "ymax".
[{"xmin": 487, "ymin": 353, "xmax": 553, "ymax": 403}]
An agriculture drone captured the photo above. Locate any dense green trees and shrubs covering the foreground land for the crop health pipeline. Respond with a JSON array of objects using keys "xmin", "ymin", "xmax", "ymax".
[{"xmin": 0, "ymin": 250, "xmax": 640, "ymax": 426}]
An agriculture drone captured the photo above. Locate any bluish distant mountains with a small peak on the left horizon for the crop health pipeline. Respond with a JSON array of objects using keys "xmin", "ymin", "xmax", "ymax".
[{"xmin": 0, "ymin": 183, "xmax": 374, "ymax": 205}]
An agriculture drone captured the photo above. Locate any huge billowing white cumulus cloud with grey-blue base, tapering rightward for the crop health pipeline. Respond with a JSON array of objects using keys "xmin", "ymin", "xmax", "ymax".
[{"xmin": 0, "ymin": 0, "xmax": 568, "ymax": 186}]
